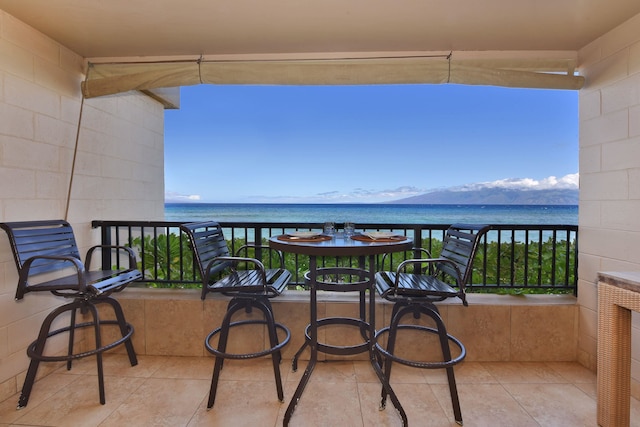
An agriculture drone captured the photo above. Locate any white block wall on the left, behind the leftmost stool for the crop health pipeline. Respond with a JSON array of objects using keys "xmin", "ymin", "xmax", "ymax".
[{"xmin": 0, "ymin": 10, "xmax": 164, "ymax": 400}]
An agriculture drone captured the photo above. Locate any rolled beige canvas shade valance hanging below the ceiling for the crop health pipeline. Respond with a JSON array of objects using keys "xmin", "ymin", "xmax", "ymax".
[{"xmin": 82, "ymin": 55, "xmax": 584, "ymax": 98}]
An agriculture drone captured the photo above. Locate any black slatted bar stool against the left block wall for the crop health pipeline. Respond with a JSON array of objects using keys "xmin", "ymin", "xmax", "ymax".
[{"xmin": 0, "ymin": 220, "xmax": 142, "ymax": 409}]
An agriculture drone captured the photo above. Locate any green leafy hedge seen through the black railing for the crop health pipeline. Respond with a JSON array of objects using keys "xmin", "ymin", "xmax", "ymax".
[{"xmin": 132, "ymin": 233, "xmax": 576, "ymax": 294}]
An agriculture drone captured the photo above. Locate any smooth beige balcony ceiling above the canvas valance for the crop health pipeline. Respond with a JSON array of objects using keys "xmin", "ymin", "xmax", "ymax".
[{"xmin": 0, "ymin": 0, "xmax": 640, "ymax": 59}]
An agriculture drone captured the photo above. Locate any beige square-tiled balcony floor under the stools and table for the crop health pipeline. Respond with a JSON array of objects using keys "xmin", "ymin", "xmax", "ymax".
[{"xmin": 0, "ymin": 354, "xmax": 640, "ymax": 427}]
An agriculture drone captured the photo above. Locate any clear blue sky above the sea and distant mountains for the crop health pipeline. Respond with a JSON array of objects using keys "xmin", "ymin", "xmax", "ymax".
[{"xmin": 165, "ymin": 85, "xmax": 578, "ymax": 203}]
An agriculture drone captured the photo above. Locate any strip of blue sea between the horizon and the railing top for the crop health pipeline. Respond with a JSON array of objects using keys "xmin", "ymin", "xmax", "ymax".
[{"xmin": 165, "ymin": 203, "xmax": 578, "ymax": 225}]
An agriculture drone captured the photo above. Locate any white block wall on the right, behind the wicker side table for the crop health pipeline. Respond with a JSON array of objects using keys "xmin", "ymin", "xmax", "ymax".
[{"xmin": 578, "ymin": 11, "xmax": 640, "ymax": 397}]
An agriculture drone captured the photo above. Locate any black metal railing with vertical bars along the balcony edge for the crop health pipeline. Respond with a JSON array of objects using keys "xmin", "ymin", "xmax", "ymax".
[{"xmin": 92, "ymin": 221, "xmax": 578, "ymax": 294}]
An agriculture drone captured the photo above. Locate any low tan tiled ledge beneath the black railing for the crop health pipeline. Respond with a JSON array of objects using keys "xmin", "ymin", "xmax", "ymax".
[{"xmin": 111, "ymin": 288, "xmax": 578, "ymax": 361}]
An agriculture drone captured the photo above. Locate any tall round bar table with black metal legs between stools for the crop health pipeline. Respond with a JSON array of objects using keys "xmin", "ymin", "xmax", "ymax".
[{"xmin": 269, "ymin": 234, "xmax": 413, "ymax": 426}]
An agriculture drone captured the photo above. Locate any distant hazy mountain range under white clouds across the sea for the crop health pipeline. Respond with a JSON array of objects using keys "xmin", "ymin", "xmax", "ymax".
[{"xmin": 389, "ymin": 187, "xmax": 578, "ymax": 205}]
